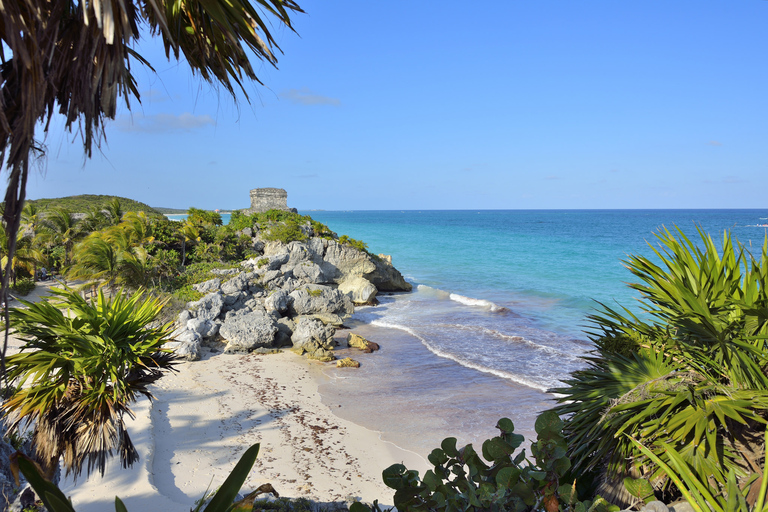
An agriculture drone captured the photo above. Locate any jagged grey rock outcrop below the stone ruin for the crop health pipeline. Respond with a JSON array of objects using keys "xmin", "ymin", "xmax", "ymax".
[{"xmin": 167, "ymin": 222, "xmax": 411, "ymax": 361}]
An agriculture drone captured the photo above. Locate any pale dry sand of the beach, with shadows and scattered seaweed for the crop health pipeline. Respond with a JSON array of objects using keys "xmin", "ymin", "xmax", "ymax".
[{"xmin": 62, "ymin": 352, "xmax": 427, "ymax": 512}]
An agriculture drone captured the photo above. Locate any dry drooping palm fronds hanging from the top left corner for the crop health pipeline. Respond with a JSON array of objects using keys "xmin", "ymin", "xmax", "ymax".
[{"xmin": 0, "ymin": 0, "xmax": 303, "ymax": 330}]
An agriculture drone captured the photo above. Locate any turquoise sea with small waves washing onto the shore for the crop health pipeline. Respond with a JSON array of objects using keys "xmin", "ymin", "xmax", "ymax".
[{"xmin": 300, "ymin": 210, "xmax": 768, "ymax": 455}]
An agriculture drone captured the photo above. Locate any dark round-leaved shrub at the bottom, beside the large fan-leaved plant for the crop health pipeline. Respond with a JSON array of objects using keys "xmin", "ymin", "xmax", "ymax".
[{"xmin": 351, "ymin": 411, "xmax": 619, "ymax": 512}]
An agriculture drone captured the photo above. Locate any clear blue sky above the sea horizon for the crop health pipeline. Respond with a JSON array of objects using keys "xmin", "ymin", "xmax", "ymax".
[{"xmin": 28, "ymin": 0, "xmax": 768, "ymax": 210}]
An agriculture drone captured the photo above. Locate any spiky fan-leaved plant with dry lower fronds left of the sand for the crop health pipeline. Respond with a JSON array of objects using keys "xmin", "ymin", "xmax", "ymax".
[{"xmin": 3, "ymin": 288, "xmax": 173, "ymax": 478}]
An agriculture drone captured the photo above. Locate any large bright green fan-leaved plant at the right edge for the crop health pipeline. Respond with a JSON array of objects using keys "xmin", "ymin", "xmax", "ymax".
[{"xmin": 553, "ymin": 230, "xmax": 768, "ymax": 506}]
